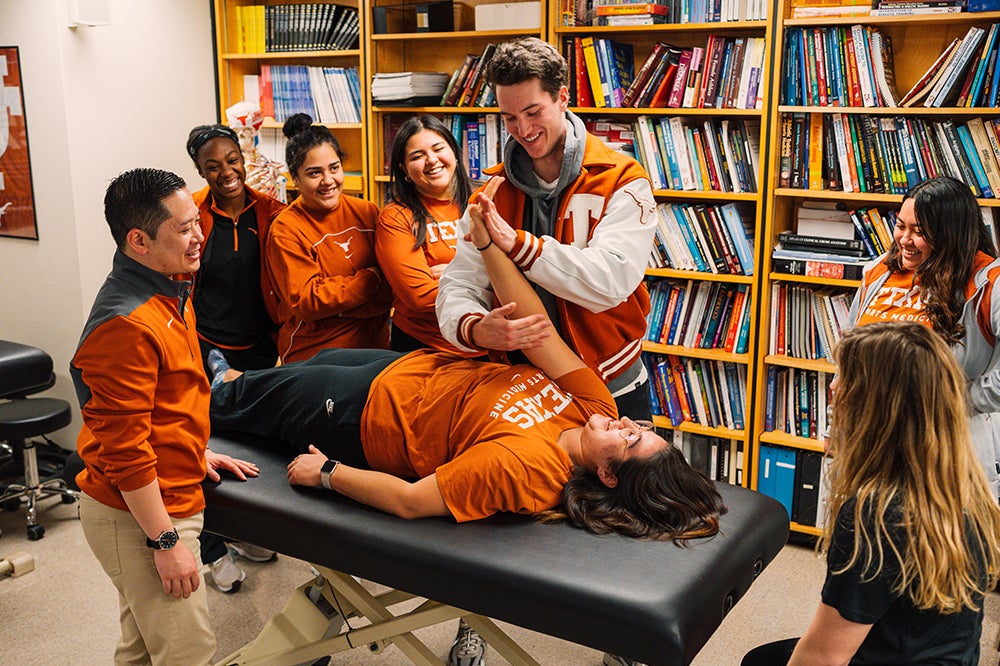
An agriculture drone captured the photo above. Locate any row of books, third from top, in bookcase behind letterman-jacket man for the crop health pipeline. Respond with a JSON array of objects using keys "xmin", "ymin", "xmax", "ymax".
[{"xmin": 634, "ymin": 116, "xmax": 760, "ymax": 192}]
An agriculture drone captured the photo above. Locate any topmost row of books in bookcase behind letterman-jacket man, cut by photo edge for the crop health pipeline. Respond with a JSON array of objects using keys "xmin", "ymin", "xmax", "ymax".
[{"xmin": 559, "ymin": 0, "xmax": 771, "ymax": 28}]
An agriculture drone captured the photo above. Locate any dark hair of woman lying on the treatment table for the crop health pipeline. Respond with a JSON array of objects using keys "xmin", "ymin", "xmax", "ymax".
[{"xmin": 539, "ymin": 444, "xmax": 726, "ymax": 544}]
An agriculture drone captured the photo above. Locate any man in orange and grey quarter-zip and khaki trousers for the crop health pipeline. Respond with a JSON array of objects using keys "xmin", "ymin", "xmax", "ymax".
[{"xmin": 70, "ymin": 169, "xmax": 257, "ymax": 664}]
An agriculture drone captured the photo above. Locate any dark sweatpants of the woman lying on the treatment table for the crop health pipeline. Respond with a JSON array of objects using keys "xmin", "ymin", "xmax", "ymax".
[{"xmin": 211, "ymin": 349, "xmax": 402, "ymax": 468}]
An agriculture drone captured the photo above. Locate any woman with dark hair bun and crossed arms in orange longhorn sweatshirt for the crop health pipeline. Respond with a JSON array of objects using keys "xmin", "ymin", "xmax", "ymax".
[{"xmin": 266, "ymin": 114, "xmax": 392, "ymax": 363}]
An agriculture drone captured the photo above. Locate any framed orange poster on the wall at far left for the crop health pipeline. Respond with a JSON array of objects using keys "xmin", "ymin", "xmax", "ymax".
[{"xmin": 0, "ymin": 46, "xmax": 38, "ymax": 240}]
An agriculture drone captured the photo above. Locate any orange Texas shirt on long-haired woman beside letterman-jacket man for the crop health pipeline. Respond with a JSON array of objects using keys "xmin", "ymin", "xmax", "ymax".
[{"xmin": 375, "ymin": 199, "xmax": 478, "ymax": 356}]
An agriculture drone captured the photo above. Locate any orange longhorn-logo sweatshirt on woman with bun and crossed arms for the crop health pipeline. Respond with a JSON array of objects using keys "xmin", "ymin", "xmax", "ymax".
[{"xmin": 265, "ymin": 195, "xmax": 392, "ymax": 363}]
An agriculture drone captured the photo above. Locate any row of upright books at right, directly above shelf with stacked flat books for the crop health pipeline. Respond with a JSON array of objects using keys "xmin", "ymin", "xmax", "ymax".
[{"xmin": 779, "ymin": 113, "xmax": 1000, "ymax": 198}]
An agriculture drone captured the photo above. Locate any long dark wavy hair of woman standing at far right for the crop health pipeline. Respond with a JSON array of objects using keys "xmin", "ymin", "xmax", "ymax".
[{"xmin": 885, "ymin": 176, "xmax": 997, "ymax": 345}]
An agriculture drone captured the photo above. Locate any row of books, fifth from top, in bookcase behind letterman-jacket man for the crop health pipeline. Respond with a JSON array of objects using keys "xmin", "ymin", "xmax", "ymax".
[{"xmin": 646, "ymin": 280, "xmax": 753, "ymax": 354}]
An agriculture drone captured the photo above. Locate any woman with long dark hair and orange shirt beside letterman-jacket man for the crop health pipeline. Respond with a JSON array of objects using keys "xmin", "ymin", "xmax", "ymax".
[{"xmin": 375, "ymin": 114, "xmax": 475, "ymax": 356}]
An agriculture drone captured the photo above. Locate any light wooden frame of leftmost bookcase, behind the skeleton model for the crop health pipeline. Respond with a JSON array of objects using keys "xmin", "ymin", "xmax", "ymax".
[{"xmin": 212, "ymin": 0, "xmax": 369, "ymax": 198}]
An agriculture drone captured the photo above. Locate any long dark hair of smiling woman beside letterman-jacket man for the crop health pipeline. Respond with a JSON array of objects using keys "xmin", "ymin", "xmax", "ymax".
[{"xmin": 389, "ymin": 114, "xmax": 472, "ymax": 249}]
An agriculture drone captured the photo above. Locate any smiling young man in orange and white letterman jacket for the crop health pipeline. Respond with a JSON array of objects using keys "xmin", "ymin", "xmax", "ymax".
[{"xmin": 436, "ymin": 38, "xmax": 656, "ymax": 419}]
